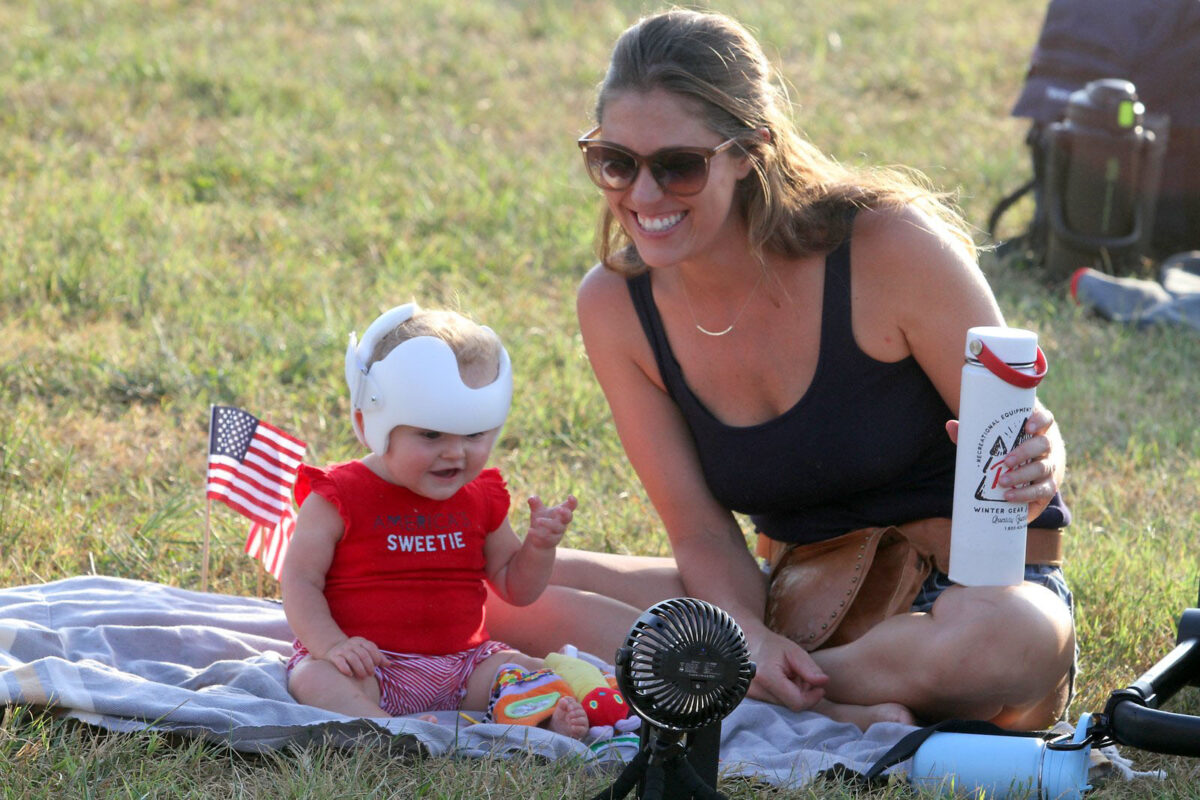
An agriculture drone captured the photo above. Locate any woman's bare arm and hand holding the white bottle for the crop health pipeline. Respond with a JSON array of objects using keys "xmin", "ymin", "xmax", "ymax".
[{"xmin": 854, "ymin": 209, "xmax": 1066, "ymax": 519}]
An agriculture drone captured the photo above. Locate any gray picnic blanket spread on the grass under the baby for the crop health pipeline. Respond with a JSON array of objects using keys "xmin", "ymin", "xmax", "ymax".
[{"xmin": 0, "ymin": 576, "xmax": 912, "ymax": 787}]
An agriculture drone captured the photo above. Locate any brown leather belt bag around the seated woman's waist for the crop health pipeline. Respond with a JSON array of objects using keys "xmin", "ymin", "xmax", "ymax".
[{"xmin": 757, "ymin": 517, "xmax": 1062, "ymax": 650}]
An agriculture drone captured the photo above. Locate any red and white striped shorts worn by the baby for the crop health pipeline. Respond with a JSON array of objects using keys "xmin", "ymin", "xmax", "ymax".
[{"xmin": 295, "ymin": 639, "xmax": 512, "ymax": 716}]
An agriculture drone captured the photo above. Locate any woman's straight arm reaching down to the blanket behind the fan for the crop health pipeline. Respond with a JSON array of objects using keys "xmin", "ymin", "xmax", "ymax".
[{"xmin": 577, "ymin": 266, "xmax": 827, "ymax": 709}]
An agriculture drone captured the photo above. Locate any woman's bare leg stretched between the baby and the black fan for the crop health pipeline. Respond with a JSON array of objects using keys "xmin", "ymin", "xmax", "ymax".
[{"xmin": 487, "ymin": 548, "xmax": 685, "ymax": 661}]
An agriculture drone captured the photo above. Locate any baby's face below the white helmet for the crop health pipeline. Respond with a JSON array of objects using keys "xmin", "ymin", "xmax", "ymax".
[{"xmin": 382, "ymin": 425, "xmax": 500, "ymax": 500}]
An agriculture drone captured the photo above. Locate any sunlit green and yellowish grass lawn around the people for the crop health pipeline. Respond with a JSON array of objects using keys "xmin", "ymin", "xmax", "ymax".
[{"xmin": 0, "ymin": 0, "xmax": 1200, "ymax": 798}]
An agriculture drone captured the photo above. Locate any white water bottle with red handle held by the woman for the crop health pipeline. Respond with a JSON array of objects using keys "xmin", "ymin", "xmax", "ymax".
[{"xmin": 949, "ymin": 327, "xmax": 1046, "ymax": 587}]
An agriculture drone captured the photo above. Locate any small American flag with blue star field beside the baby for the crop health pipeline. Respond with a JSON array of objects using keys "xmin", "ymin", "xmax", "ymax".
[{"xmin": 208, "ymin": 405, "xmax": 307, "ymax": 529}]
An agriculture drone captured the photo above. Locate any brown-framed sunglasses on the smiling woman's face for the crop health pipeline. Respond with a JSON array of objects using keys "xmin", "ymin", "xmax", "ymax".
[{"xmin": 578, "ymin": 126, "xmax": 737, "ymax": 197}]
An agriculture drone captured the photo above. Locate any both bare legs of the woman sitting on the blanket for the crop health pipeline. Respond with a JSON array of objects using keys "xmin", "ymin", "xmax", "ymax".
[{"xmin": 487, "ymin": 548, "xmax": 1075, "ymax": 729}]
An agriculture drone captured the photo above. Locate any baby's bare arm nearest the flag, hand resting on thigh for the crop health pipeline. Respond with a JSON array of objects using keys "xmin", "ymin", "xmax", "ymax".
[{"xmin": 280, "ymin": 494, "xmax": 383, "ymax": 678}]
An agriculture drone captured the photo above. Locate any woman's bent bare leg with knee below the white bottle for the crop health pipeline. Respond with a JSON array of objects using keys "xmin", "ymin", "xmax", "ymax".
[{"xmin": 812, "ymin": 583, "xmax": 1075, "ymax": 729}]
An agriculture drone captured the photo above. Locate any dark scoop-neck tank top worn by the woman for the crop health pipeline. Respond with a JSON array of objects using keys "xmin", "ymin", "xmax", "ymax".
[{"xmin": 628, "ymin": 231, "xmax": 1064, "ymax": 542}]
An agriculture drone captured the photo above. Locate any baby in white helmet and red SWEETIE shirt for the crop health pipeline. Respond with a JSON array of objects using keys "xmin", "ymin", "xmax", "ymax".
[{"xmin": 281, "ymin": 303, "xmax": 588, "ymax": 739}]
